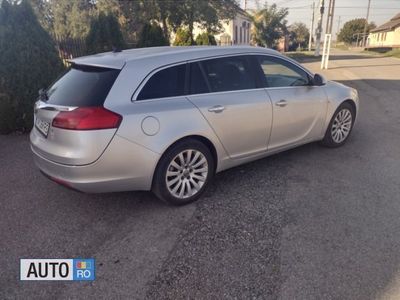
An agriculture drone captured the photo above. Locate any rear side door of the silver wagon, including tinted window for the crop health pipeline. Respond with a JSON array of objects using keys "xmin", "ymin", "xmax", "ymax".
[{"xmin": 188, "ymin": 56, "xmax": 272, "ymax": 158}]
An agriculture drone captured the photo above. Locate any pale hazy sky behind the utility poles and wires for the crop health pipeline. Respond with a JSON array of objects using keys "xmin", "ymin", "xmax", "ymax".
[{"xmin": 241, "ymin": 0, "xmax": 400, "ymax": 35}]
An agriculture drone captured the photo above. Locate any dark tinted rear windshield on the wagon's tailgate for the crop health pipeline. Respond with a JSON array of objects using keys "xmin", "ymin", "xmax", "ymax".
[{"xmin": 46, "ymin": 65, "xmax": 120, "ymax": 106}]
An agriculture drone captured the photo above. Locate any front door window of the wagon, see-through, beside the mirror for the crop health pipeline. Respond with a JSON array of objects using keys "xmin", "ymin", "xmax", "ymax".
[{"xmin": 258, "ymin": 56, "xmax": 310, "ymax": 87}]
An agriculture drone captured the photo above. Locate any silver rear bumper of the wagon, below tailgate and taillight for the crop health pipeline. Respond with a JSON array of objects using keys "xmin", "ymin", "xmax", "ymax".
[{"xmin": 31, "ymin": 135, "xmax": 160, "ymax": 193}]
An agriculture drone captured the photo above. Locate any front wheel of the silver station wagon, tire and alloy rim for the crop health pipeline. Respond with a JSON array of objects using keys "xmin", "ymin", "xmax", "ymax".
[{"xmin": 321, "ymin": 102, "xmax": 355, "ymax": 148}]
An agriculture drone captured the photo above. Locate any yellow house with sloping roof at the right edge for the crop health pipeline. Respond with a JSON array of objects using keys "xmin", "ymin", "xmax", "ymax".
[{"xmin": 367, "ymin": 13, "xmax": 400, "ymax": 48}]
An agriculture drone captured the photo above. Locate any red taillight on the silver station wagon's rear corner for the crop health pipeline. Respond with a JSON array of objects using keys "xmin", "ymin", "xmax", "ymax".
[{"xmin": 53, "ymin": 107, "xmax": 122, "ymax": 130}]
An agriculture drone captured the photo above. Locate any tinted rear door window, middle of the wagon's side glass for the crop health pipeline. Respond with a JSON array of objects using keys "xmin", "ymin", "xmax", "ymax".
[{"xmin": 201, "ymin": 56, "xmax": 257, "ymax": 92}]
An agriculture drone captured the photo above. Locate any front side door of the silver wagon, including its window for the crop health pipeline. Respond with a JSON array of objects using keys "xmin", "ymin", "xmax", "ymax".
[{"xmin": 258, "ymin": 55, "xmax": 328, "ymax": 150}]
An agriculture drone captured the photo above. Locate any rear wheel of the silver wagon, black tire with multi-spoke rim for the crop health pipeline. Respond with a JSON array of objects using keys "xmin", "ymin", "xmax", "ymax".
[{"xmin": 152, "ymin": 139, "xmax": 215, "ymax": 205}]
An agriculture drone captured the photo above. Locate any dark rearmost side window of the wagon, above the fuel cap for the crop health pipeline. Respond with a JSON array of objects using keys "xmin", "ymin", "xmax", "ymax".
[{"xmin": 136, "ymin": 64, "xmax": 186, "ymax": 100}]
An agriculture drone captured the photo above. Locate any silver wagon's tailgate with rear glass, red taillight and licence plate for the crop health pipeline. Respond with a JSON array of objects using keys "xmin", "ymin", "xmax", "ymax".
[{"xmin": 30, "ymin": 65, "xmax": 121, "ymax": 165}]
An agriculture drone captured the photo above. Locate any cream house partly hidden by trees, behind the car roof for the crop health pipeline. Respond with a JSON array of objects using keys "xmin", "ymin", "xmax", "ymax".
[{"xmin": 193, "ymin": 9, "xmax": 252, "ymax": 46}]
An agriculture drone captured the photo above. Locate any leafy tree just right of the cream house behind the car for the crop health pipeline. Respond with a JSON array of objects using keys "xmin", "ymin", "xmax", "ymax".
[{"xmin": 253, "ymin": 4, "xmax": 289, "ymax": 48}]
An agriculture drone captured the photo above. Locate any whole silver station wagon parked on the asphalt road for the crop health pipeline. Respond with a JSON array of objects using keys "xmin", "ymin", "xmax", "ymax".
[{"xmin": 30, "ymin": 47, "xmax": 359, "ymax": 205}]
